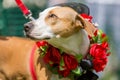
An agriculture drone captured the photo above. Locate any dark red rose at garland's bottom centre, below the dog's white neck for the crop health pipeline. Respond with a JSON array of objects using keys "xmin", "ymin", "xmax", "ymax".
[{"xmin": 63, "ymin": 54, "xmax": 78, "ymax": 70}]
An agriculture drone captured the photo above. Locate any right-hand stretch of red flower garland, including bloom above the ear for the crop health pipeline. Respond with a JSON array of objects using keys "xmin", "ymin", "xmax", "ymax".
[{"xmin": 81, "ymin": 14, "xmax": 110, "ymax": 72}]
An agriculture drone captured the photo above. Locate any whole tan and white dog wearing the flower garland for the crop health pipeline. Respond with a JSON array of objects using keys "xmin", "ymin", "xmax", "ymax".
[{"xmin": 0, "ymin": 6, "xmax": 95, "ymax": 80}]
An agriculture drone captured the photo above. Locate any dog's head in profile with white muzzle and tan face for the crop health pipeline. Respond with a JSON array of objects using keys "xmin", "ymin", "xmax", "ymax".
[{"xmin": 25, "ymin": 6, "xmax": 85, "ymax": 39}]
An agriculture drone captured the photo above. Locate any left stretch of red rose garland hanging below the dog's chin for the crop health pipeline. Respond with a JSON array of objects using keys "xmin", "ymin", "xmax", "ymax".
[{"xmin": 37, "ymin": 41, "xmax": 82, "ymax": 78}]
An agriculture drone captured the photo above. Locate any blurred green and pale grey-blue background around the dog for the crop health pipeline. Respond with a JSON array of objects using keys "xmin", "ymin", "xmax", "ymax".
[{"xmin": 0, "ymin": 0, "xmax": 120, "ymax": 80}]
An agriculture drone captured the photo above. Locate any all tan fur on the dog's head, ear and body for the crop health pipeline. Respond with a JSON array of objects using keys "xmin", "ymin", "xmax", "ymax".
[{"xmin": 0, "ymin": 7, "xmax": 96, "ymax": 80}]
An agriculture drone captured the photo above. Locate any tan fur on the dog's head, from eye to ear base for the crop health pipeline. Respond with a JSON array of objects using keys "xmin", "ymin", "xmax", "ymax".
[{"xmin": 45, "ymin": 7, "xmax": 83, "ymax": 37}]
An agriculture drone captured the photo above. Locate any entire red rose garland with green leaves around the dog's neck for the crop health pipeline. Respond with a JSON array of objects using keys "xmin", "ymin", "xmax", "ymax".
[{"xmin": 37, "ymin": 14, "xmax": 110, "ymax": 80}]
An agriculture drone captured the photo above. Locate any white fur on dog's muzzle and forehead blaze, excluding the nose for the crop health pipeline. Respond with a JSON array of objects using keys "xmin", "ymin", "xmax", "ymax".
[{"xmin": 29, "ymin": 7, "xmax": 60, "ymax": 39}]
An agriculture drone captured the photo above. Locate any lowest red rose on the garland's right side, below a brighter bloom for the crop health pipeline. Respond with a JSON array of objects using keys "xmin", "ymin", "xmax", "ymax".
[{"xmin": 92, "ymin": 58, "xmax": 108, "ymax": 72}]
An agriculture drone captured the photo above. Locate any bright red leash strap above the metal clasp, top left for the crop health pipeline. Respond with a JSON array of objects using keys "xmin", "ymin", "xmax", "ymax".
[{"xmin": 15, "ymin": 0, "xmax": 30, "ymax": 16}]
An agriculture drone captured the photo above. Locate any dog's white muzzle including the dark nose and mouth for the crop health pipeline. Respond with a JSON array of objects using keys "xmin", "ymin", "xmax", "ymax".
[{"xmin": 24, "ymin": 19, "xmax": 55, "ymax": 40}]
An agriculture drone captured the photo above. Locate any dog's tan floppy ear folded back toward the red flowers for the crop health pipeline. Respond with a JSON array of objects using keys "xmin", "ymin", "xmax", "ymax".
[{"xmin": 75, "ymin": 15, "xmax": 96, "ymax": 35}]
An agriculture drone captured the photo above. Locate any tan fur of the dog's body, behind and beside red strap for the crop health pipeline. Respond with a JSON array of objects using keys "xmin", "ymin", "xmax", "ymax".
[{"xmin": 0, "ymin": 37, "xmax": 50, "ymax": 80}]
